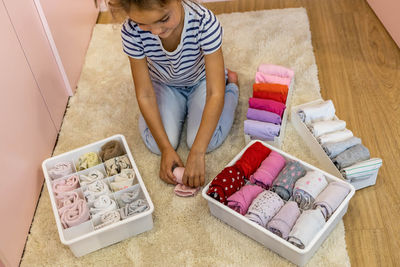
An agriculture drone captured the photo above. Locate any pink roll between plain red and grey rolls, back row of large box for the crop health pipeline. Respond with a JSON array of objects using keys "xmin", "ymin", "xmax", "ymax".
[{"xmin": 250, "ymin": 150, "xmax": 286, "ymax": 189}]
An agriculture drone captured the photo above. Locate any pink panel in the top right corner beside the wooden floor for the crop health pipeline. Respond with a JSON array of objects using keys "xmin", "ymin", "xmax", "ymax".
[{"xmin": 367, "ymin": 0, "xmax": 400, "ymax": 47}]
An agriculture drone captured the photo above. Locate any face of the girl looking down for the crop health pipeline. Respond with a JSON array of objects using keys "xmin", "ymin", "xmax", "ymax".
[{"xmin": 129, "ymin": 0, "xmax": 184, "ymax": 39}]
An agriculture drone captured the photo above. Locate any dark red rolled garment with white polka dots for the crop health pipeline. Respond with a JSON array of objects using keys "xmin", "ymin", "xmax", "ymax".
[{"xmin": 207, "ymin": 165, "xmax": 245, "ymax": 205}]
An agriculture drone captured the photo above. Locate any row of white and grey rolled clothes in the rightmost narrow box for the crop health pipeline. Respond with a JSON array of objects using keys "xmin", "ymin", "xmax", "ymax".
[{"xmin": 298, "ymin": 100, "xmax": 382, "ymax": 181}]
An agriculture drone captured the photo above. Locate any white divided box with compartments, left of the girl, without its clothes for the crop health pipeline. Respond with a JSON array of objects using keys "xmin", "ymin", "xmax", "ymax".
[{"xmin": 42, "ymin": 135, "xmax": 154, "ymax": 257}]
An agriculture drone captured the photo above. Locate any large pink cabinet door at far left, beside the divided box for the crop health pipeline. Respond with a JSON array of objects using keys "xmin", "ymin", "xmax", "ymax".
[{"xmin": 0, "ymin": 0, "xmax": 57, "ymax": 266}]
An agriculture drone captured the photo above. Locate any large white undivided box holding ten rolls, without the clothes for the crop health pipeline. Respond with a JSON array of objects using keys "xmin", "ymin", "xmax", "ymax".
[{"xmin": 202, "ymin": 140, "xmax": 355, "ymax": 266}]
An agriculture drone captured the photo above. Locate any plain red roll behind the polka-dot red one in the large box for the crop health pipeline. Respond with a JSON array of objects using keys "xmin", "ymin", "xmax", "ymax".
[{"xmin": 235, "ymin": 142, "xmax": 271, "ymax": 179}]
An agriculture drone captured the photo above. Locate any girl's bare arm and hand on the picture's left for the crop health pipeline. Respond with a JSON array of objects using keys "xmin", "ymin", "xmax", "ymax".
[{"xmin": 129, "ymin": 57, "xmax": 183, "ymax": 184}]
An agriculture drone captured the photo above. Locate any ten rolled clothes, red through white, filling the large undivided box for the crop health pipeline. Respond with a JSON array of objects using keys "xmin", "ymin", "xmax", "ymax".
[{"xmin": 207, "ymin": 142, "xmax": 350, "ymax": 249}]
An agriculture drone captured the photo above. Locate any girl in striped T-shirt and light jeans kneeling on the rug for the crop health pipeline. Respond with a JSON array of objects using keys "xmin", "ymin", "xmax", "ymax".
[{"xmin": 109, "ymin": 0, "xmax": 239, "ymax": 187}]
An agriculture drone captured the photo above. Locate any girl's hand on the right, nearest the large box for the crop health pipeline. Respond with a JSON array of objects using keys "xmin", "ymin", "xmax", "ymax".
[{"xmin": 182, "ymin": 150, "xmax": 205, "ymax": 187}]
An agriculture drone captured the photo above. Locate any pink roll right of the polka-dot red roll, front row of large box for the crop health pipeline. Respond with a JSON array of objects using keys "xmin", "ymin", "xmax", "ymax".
[{"xmin": 228, "ymin": 185, "xmax": 263, "ymax": 215}]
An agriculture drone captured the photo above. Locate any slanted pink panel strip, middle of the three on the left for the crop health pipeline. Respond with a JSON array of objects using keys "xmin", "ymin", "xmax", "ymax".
[{"xmin": 3, "ymin": 0, "xmax": 68, "ymax": 130}]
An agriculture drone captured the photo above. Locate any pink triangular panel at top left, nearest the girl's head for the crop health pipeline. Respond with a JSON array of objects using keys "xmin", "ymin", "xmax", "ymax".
[{"xmin": 36, "ymin": 0, "xmax": 98, "ymax": 92}]
